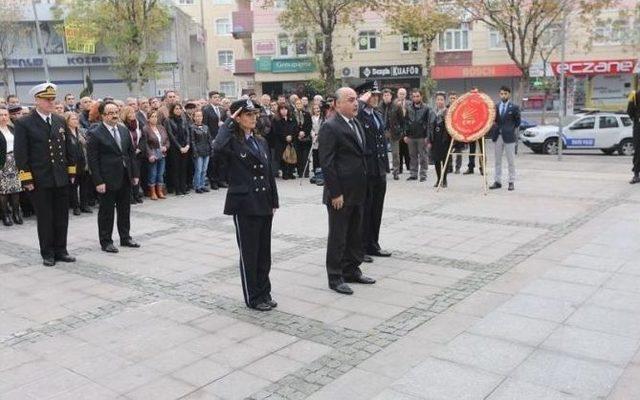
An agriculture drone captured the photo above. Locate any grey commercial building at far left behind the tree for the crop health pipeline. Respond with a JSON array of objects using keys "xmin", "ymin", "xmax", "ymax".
[{"xmin": 0, "ymin": 0, "xmax": 205, "ymax": 103}]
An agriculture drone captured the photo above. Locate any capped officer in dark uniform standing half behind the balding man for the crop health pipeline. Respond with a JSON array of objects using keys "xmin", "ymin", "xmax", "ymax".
[{"xmin": 356, "ymin": 81, "xmax": 391, "ymax": 262}]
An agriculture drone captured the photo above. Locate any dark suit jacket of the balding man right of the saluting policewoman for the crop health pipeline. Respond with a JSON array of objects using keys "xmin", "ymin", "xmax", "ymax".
[{"xmin": 318, "ymin": 114, "xmax": 367, "ymax": 206}]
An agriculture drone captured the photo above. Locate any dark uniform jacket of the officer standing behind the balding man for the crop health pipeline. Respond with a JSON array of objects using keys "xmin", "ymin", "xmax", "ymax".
[{"xmin": 357, "ymin": 102, "xmax": 389, "ymax": 177}]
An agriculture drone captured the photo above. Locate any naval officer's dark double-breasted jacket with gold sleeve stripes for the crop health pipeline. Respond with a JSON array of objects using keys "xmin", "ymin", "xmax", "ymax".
[{"xmin": 13, "ymin": 109, "xmax": 76, "ymax": 188}]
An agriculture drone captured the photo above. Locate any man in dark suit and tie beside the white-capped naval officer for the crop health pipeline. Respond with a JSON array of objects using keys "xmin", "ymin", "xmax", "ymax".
[{"xmin": 87, "ymin": 101, "xmax": 140, "ymax": 253}]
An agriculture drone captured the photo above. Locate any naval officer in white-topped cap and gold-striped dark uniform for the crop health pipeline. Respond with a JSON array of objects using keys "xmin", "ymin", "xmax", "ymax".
[{"xmin": 14, "ymin": 82, "xmax": 76, "ymax": 267}]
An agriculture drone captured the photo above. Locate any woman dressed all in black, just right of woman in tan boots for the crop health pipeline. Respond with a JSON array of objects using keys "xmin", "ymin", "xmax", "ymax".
[{"xmin": 164, "ymin": 103, "xmax": 190, "ymax": 195}]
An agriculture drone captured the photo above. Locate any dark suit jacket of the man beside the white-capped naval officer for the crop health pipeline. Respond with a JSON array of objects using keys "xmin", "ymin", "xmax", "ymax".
[{"xmin": 87, "ymin": 123, "xmax": 140, "ymax": 190}]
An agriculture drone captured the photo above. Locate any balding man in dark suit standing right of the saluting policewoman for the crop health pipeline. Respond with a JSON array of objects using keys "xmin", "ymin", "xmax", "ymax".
[{"xmin": 318, "ymin": 87, "xmax": 375, "ymax": 294}]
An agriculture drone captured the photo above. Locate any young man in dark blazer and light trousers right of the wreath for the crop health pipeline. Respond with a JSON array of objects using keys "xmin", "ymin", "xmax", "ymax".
[{"xmin": 489, "ymin": 86, "xmax": 520, "ymax": 190}]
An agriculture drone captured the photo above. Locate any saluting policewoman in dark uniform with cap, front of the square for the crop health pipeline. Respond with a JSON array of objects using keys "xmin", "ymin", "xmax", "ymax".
[{"xmin": 213, "ymin": 99, "xmax": 279, "ymax": 311}]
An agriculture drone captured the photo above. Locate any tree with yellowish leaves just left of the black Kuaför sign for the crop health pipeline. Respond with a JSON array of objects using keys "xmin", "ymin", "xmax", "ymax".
[{"xmin": 263, "ymin": 0, "xmax": 377, "ymax": 93}]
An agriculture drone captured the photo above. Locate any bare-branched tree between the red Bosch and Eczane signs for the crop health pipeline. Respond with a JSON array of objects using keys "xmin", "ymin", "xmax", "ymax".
[{"xmin": 455, "ymin": 0, "xmax": 616, "ymax": 99}]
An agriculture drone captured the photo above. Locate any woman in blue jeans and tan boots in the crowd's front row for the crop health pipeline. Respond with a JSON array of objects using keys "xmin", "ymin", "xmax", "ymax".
[{"xmin": 142, "ymin": 110, "xmax": 171, "ymax": 200}]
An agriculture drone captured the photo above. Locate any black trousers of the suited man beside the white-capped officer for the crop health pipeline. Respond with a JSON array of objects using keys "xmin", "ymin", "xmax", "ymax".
[{"xmin": 98, "ymin": 171, "xmax": 131, "ymax": 247}]
